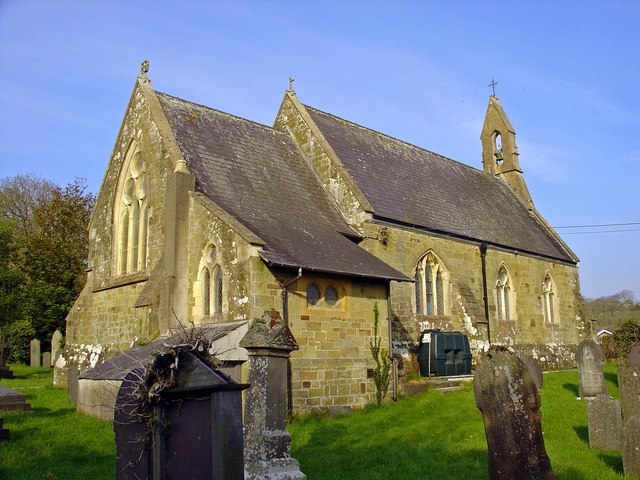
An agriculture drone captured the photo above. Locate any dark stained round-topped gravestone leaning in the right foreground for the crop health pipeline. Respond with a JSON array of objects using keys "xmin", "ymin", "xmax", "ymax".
[{"xmin": 473, "ymin": 346, "xmax": 555, "ymax": 480}]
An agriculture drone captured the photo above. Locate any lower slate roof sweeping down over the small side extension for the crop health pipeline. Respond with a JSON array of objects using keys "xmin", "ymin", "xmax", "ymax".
[{"xmin": 157, "ymin": 92, "xmax": 409, "ymax": 281}]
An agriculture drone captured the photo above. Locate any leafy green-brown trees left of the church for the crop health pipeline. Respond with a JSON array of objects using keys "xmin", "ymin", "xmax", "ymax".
[{"xmin": 0, "ymin": 175, "xmax": 94, "ymax": 348}]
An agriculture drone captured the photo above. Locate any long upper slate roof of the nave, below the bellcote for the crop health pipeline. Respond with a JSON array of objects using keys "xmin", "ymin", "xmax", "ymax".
[{"xmin": 305, "ymin": 106, "xmax": 576, "ymax": 263}]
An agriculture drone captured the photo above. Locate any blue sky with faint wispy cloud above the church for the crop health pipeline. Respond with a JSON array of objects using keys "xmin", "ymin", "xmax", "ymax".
[{"xmin": 0, "ymin": 0, "xmax": 640, "ymax": 300}]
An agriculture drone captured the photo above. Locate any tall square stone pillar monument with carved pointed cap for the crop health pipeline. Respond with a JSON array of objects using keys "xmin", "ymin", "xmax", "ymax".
[{"xmin": 240, "ymin": 310, "xmax": 307, "ymax": 480}]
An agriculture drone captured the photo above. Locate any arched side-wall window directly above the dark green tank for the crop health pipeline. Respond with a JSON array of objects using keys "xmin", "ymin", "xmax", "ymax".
[{"xmin": 415, "ymin": 252, "xmax": 449, "ymax": 315}]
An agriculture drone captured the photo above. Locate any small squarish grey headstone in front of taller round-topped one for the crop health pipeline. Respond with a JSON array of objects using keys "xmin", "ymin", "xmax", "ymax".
[{"xmin": 587, "ymin": 394, "xmax": 622, "ymax": 451}]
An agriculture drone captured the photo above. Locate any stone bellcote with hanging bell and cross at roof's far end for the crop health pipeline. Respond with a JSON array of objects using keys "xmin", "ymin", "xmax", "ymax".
[{"xmin": 480, "ymin": 95, "xmax": 533, "ymax": 207}]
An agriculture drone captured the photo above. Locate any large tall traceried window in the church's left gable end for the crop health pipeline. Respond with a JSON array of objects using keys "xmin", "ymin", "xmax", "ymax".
[{"xmin": 114, "ymin": 142, "xmax": 149, "ymax": 275}]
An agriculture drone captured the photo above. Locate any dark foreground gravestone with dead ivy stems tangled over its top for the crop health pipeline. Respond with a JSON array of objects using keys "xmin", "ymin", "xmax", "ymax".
[{"xmin": 114, "ymin": 347, "xmax": 248, "ymax": 480}]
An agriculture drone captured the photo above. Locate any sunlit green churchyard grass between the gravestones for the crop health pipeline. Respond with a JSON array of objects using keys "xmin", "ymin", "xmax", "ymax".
[{"xmin": 0, "ymin": 365, "xmax": 624, "ymax": 480}]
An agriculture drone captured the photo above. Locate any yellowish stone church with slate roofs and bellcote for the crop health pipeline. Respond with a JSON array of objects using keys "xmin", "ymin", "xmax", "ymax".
[{"xmin": 56, "ymin": 67, "xmax": 589, "ymax": 411}]
